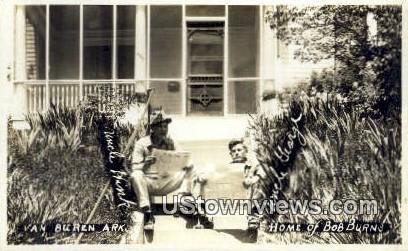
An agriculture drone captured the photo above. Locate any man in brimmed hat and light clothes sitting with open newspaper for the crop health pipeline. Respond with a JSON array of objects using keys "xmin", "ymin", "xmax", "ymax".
[{"xmin": 130, "ymin": 110, "xmax": 205, "ymax": 230}]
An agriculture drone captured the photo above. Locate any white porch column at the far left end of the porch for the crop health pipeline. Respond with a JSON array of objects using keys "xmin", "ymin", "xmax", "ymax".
[{"xmin": 13, "ymin": 5, "xmax": 28, "ymax": 117}]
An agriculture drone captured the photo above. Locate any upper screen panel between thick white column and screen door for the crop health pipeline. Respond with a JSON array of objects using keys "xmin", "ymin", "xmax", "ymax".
[{"xmin": 150, "ymin": 6, "xmax": 182, "ymax": 78}]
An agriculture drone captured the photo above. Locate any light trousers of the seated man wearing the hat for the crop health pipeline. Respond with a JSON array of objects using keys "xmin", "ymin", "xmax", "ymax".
[{"xmin": 131, "ymin": 168, "xmax": 197, "ymax": 208}]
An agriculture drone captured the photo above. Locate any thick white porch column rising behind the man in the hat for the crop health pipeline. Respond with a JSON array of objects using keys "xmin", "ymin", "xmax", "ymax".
[{"xmin": 135, "ymin": 5, "xmax": 147, "ymax": 92}]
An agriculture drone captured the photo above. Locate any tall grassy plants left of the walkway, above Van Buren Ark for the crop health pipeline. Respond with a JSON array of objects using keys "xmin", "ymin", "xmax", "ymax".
[{"xmin": 7, "ymin": 88, "xmax": 145, "ymax": 244}]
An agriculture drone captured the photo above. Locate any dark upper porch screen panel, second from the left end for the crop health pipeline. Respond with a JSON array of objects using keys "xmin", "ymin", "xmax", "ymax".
[{"xmin": 50, "ymin": 5, "xmax": 79, "ymax": 79}]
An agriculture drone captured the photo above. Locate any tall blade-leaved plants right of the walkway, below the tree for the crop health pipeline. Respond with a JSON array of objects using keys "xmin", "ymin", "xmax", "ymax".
[{"xmin": 251, "ymin": 95, "xmax": 401, "ymax": 243}]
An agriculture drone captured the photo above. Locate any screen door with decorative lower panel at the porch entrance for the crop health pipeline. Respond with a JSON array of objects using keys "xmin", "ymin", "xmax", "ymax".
[{"xmin": 187, "ymin": 21, "xmax": 224, "ymax": 116}]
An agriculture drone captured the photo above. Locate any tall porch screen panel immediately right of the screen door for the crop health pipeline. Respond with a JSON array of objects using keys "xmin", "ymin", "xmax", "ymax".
[{"xmin": 228, "ymin": 6, "xmax": 260, "ymax": 114}]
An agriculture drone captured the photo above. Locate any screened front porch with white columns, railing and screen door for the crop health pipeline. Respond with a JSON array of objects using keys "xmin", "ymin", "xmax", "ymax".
[{"xmin": 10, "ymin": 3, "xmax": 285, "ymax": 119}]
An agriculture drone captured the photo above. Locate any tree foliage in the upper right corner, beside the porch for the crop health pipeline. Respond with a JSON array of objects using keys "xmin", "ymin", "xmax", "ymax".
[{"xmin": 265, "ymin": 5, "xmax": 402, "ymax": 115}]
